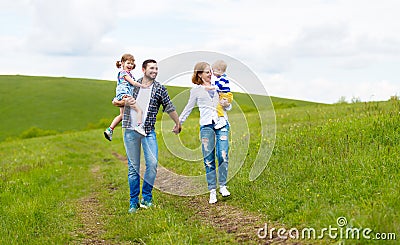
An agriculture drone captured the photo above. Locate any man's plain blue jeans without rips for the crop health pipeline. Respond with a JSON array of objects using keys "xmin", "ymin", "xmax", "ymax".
[{"xmin": 124, "ymin": 129, "xmax": 158, "ymax": 207}]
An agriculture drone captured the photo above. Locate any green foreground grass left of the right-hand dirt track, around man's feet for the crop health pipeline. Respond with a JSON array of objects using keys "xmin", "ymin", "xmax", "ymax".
[{"xmin": 0, "ymin": 130, "xmax": 236, "ymax": 244}]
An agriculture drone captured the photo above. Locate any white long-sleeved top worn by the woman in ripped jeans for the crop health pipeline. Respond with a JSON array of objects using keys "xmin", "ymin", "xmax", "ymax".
[{"xmin": 179, "ymin": 85, "xmax": 232, "ymax": 126}]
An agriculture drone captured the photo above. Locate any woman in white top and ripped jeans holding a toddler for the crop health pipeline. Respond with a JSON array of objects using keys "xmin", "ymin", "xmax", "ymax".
[{"xmin": 179, "ymin": 62, "xmax": 230, "ymax": 204}]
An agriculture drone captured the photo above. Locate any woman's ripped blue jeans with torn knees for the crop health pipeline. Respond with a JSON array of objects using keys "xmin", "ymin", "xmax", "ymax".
[{"xmin": 200, "ymin": 124, "xmax": 229, "ymax": 190}]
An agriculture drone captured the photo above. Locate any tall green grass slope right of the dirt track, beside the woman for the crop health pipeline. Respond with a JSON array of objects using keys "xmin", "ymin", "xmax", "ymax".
[{"xmin": 156, "ymin": 101, "xmax": 400, "ymax": 243}]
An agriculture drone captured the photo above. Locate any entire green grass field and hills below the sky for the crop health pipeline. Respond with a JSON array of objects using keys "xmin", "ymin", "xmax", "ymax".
[{"xmin": 0, "ymin": 76, "xmax": 400, "ymax": 244}]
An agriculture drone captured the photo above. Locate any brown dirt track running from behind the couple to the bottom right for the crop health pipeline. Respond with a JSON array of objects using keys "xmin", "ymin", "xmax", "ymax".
[{"xmin": 113, "ymin": 153, "xmax": 299, "ymax": 244}]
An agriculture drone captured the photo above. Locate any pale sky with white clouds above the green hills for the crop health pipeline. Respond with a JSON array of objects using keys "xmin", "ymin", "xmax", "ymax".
[{"xmin": 0, "ymin": 0, "xmax": 400, "ymax": 103}]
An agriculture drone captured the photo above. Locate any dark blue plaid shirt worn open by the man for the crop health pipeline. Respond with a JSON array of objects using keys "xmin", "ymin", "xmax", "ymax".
[{"xmin": 122, "ymin": 78, "xmax": 175, "ymax": 134}]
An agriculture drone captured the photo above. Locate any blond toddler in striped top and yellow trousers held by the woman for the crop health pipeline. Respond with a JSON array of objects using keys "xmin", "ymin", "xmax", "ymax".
[{"xmin": 211, "ymin": 60, "xmax": 233, "ymax": 129}]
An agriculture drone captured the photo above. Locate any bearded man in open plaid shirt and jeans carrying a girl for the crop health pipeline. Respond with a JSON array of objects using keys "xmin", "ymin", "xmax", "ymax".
[{"xmin": 113, "ymin": 59, "xmax": 181, "ymax": 213}]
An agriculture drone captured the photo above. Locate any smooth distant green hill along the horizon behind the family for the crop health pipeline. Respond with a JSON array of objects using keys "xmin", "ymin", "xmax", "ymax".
[{"xmin": 0, "ymin": 76, "xmax": 314, "ymax": 141}]
